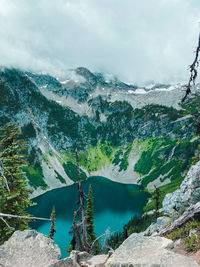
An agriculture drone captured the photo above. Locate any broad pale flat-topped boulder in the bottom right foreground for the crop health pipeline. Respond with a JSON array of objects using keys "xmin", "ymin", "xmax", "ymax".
[{"xmin": 105, "ymin": 233, "xmax": 199, "ymax": 267}]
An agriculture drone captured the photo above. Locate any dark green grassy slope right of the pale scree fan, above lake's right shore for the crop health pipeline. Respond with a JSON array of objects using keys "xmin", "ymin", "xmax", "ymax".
[{"xmin": 134, "ymin": 136, "xmax": 199, "ymax": 212}]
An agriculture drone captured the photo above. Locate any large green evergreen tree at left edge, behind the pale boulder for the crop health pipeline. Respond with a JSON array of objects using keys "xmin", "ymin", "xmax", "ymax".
[{"xmin": 0, "ymin": 123, "xmax": 32, "ymax": 244}]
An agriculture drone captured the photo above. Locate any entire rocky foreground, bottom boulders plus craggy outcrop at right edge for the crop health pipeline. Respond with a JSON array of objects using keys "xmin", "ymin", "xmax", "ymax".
[{"xmin": 0, "ymin": 161, "xmax": 200, "ymax": 267}]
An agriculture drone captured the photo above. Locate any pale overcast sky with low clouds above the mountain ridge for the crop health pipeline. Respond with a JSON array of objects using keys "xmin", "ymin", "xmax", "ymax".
[{"xmin": 0, "ymin": 0, "xmax": 200, "ymax": 83}]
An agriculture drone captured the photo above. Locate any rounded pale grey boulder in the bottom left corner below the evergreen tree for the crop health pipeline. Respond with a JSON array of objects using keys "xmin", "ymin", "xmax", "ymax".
[{"xmin": 0, "ymin": 230, "xmax": 61, "ymax": 267}]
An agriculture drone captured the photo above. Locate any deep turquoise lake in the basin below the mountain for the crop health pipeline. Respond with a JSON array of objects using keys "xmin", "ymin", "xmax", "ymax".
[{"xmin": 28, "ymin": 177, "xmax": 148, "ymax": 257}]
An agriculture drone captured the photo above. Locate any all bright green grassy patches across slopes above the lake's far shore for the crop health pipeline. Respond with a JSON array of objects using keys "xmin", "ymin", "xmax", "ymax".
[{"xmin": 25, "ymin": 127, "xmax": 198, "ymax": 197}]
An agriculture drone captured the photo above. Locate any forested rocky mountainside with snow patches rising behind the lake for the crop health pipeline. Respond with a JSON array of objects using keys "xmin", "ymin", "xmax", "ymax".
[{"xmin": 0, "ymin": 67, "xmax": 200, "ymax": 200}]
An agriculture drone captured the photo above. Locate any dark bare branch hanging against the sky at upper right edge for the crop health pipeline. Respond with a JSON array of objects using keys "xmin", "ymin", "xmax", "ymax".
[{"xmin": 181, "ymin": 31, "xmax": 200, "ymax": 103}]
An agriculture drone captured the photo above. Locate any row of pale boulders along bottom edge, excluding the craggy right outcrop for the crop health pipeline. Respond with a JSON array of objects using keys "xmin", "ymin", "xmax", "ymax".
[{"xmin": 0, "ymin": 230, "xmax": 199, "ymax": 267}]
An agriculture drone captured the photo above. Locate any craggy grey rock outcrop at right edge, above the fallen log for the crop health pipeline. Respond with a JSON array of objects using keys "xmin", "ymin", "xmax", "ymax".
[{"xmin": 163, "ymin": 161, "xmax": 200, "ymax": 219}]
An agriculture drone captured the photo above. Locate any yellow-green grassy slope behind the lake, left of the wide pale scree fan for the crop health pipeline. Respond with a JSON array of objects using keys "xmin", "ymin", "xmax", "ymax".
[{"xmin": 35, "ymin": 141, "xmax": 137, "ymax": 187}]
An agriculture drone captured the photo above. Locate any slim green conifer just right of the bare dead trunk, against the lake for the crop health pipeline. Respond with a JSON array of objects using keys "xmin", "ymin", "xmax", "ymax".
[{"xmin": 86, "ymin": 185, "xmax": 99, "ymax": 254}]
